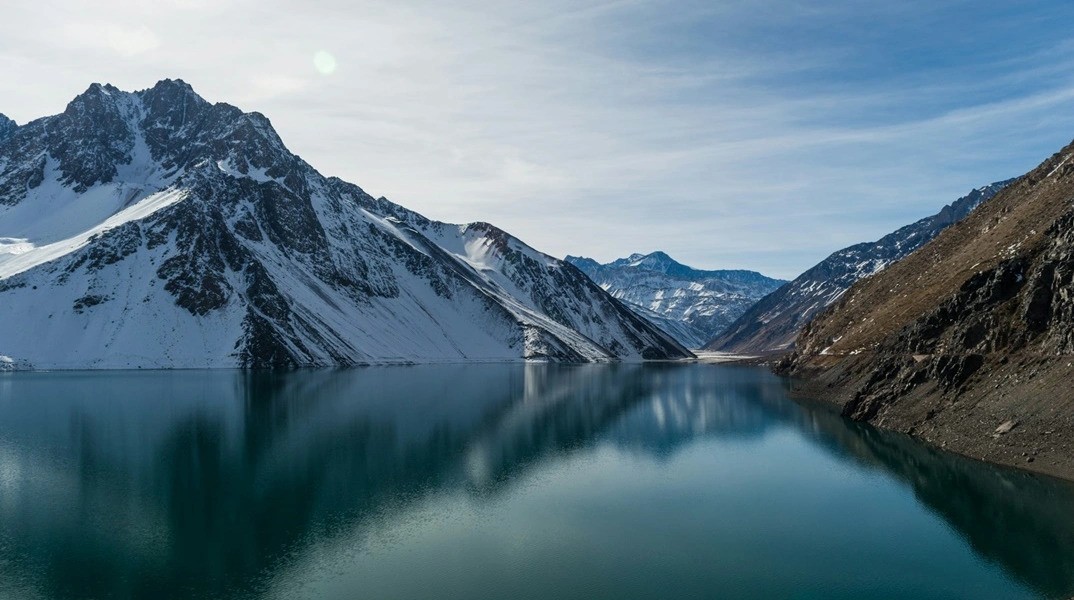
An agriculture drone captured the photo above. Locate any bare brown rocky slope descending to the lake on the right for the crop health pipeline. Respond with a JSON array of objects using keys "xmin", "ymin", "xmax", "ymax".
[{"xmin": 783, "ymin": 140, "xmax": 1074, "ymax": 477}]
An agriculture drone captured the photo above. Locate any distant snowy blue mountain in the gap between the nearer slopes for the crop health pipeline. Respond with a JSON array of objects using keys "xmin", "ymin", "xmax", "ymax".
[{"xmin": 565, "ymin": 252, "xmax": 786, "ymax": 348}]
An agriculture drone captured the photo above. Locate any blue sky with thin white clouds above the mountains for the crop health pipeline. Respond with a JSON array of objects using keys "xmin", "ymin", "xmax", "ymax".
[{"xmin": 0, "ymin": 0, "xmax": 1074, "ymax": 278}]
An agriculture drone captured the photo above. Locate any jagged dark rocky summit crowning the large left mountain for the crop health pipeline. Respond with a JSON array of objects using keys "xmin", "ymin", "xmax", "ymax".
[{"xmin": 0, "ymin": 79, "xmax": 308, "ymax": 205}]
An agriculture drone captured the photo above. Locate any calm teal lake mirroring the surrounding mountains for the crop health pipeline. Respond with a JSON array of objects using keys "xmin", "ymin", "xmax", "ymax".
[{"xmin": 0, "ymin": 364, "xmax": 1074, "ymax": 600}]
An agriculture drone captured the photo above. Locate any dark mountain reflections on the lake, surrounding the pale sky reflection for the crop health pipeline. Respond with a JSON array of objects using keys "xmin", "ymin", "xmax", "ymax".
[{"xmin": 0, "ymin": 364, "xmax": 1074, "ymax": 598}]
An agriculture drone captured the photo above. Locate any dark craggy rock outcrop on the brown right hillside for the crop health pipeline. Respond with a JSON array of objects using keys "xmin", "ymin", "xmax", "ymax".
[{"xmin": 811, "ymin": 211, "xmax": 1074, "ymax": 421}]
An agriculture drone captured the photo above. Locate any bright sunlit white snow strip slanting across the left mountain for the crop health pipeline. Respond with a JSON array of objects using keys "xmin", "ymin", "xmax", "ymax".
[{"xmin": 0, "ymin": 190, "xmax": 187, "ymax": 280}]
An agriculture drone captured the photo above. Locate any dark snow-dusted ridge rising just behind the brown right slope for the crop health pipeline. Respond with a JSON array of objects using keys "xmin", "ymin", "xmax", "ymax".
[{"xmin": 705, "ymin": 179, "xmax": 1014, "ymax": 354}]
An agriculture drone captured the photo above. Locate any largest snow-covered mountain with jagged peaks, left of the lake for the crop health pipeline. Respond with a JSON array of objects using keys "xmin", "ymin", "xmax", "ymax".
[{"xmin": 0, "ymin": 81, "xmax": 690, "ymax": 368}]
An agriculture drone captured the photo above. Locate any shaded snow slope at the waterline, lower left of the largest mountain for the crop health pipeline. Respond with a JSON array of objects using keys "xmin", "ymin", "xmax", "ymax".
[{"xmin": 0, "ymin": 237, "xmax": 243, "ymax": 369}]
